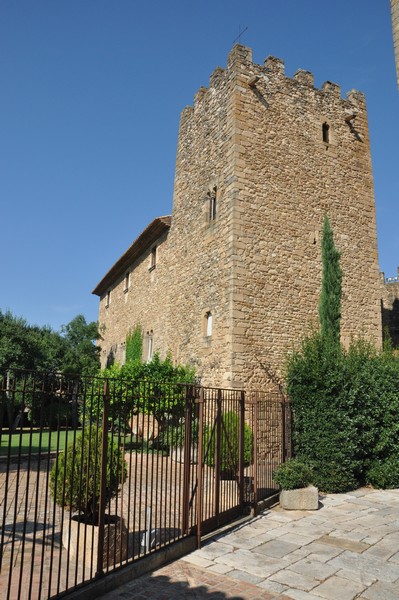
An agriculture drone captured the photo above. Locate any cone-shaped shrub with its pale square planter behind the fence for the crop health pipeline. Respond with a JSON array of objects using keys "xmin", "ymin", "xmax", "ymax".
[{"xmin": 50, "ymin": 426, "xmax": 127, "ymax": 569}]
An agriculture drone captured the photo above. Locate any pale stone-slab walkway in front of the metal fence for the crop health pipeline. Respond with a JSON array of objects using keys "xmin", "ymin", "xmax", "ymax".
[{"xmin": 103, "ymin": 489, "xmax": 399, "ymax": 600}]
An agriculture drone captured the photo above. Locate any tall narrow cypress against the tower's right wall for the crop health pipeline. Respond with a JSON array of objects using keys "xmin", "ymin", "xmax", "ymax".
[{"xmin": 319, "ymin": 216, "xmax": 342, "ymax": 344}]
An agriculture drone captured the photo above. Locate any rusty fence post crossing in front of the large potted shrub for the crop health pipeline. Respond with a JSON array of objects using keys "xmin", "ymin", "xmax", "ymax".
[{"xmin": 96, "ymin": 379, "xmax": 109, "ymax": 577}]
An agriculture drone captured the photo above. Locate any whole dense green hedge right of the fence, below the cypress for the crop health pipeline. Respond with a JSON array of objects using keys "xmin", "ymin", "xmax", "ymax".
[{"xmin": 287, "ymin": 333, "xmax": 399, "ymax": 492}]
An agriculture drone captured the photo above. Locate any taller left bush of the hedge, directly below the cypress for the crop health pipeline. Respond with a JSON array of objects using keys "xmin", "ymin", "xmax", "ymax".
[{"xmin": 287, "ymin": 333, "xmax": 359, "ymax": 492}]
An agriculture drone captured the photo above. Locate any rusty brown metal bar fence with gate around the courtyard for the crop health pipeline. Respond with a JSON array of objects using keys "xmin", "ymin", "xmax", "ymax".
[{"xmin": 0, "ymin": 371, "xmax": 290, "ymax": 600}]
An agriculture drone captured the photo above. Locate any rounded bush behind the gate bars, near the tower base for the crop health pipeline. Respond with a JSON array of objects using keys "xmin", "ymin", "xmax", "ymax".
[{"xmin": 204, "ymin": 412, "xmax": 254, "ymax": 475}]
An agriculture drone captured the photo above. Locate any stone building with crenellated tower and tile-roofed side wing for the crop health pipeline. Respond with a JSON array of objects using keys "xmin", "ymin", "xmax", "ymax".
[{"xmin": 93, "ymin": 45, "xmax": 382, "ymax": 388}]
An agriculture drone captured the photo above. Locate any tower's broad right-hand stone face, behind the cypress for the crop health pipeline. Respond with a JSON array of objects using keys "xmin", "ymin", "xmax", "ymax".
[{"xmin": 222, "ymin": 48, "xmax": 381, "ymax": 386}]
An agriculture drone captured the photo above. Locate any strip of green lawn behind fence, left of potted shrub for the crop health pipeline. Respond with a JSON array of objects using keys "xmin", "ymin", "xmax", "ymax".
[{"xmin": 0, "ymin": 430, "xmax": 77, "ymax": 456}]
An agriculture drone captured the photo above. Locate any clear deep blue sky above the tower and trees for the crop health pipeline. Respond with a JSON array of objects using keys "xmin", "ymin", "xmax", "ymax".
[{"xmin": 0, "ymin": 0, "xmax": 399, "ymax": 330}]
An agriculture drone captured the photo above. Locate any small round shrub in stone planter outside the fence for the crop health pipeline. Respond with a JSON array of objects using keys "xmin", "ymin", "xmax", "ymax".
[{"xmin": 273, "ymin": 458, "xmax": 319, "ymax": 510}]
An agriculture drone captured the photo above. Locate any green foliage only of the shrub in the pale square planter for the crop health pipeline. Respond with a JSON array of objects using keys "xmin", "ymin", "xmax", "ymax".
[{"xmin": 50, "ymin": 427, "xmax": 127, "ymax": 524}]
